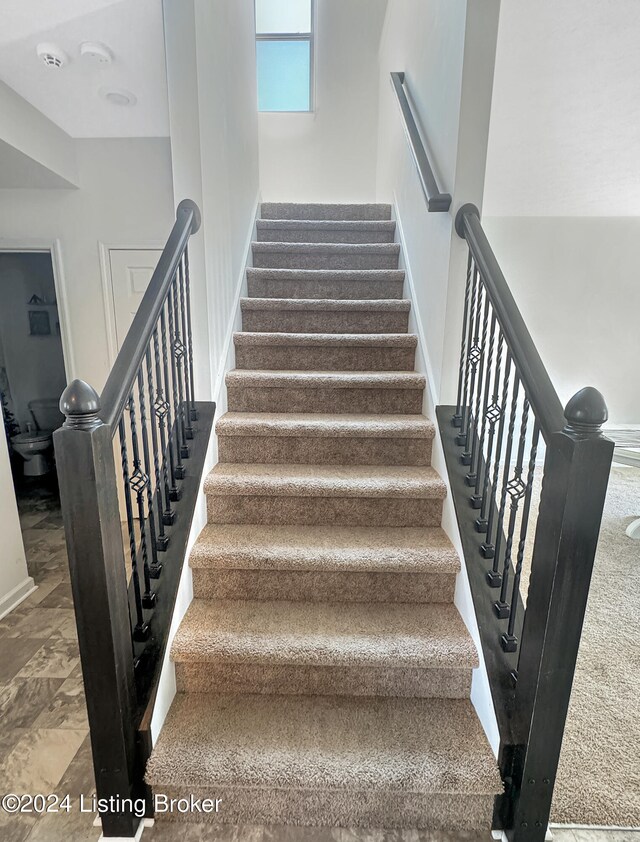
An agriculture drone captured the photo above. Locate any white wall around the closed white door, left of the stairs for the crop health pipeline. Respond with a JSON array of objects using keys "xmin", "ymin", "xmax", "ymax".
[{"xmin": 0, "ymin": 138, "xmax": 175, "ymax": 391}]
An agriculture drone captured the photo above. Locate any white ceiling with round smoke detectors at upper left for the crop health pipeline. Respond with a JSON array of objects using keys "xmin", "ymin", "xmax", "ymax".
[{"xmin": 0, "ymin": 0, "xmax": 169, "ymax": 137}]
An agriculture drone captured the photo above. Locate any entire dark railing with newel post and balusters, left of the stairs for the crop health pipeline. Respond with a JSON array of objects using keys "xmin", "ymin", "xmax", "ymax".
[{"xmin": 54, "ymin": 200, "xmax": 215, "ymax": 838}]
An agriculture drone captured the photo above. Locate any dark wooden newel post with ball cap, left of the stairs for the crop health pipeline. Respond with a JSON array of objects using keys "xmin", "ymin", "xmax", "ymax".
[{"xmin": 54, "ymin": 380, "xmax": 139, "ymax": 837}]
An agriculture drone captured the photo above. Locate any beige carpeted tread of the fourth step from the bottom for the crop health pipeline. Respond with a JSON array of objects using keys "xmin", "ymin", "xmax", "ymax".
[{"xmin": 204, "ymin": 462, "xmax": 447, "ymax": 500}]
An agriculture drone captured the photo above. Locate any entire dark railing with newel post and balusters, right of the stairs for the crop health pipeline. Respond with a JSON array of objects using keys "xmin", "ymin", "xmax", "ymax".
[{"xmin": 437, "ymin": 200, "xmax": 614, "ymax": 842}]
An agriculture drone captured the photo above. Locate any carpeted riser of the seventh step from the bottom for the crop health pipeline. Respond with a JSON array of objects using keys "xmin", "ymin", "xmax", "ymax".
[{"xmin": 236, "ymin": 345, "xmax": 416, "ymax": 371}]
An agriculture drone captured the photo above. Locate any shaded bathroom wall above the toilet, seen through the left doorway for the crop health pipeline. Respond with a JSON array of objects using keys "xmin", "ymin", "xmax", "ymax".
[{"xmin": 0, "ymin": 252, "xmax": 66, "ymax": 431}]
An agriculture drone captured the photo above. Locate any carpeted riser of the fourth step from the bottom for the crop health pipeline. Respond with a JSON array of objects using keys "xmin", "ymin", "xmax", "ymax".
[{"xmin": 207, "ymin": 494, "xmax": 442, "ymax": 526}]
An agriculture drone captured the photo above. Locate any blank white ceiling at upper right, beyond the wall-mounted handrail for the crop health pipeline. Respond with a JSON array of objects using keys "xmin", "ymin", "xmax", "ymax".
[{"xmin": 483, "ymin": 0, "xmax": 640, "ymax": 216}]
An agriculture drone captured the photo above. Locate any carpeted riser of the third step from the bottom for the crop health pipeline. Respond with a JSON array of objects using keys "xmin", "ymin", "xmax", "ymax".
[{"xmin": 191, "ymin": 567, "xmax": 456, "ymax": 603}]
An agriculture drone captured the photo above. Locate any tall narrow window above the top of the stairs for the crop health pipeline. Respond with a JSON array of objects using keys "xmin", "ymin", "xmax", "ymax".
[{"xmin": 256, "ymin": 0, "xmax": 313, "ymax": 111}]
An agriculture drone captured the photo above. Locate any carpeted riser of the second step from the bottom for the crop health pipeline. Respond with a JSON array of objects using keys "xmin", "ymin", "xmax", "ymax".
[{"xmin": 176, "ymin": 663, "xmax": 471, "ymax": 699}]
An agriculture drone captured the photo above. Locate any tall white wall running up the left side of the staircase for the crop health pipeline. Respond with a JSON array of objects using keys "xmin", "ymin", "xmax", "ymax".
[{"xmin": 151, "ymin": 0, "xmax": 259, "ymax": 740}]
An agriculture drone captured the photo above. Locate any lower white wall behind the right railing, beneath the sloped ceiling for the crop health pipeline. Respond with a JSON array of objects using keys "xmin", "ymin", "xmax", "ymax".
[{"xmin": 483, "ymin": 217, "xmax": 640, "ymax": 425}]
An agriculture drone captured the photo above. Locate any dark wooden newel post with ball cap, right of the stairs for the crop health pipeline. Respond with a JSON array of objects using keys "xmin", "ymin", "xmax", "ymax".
[{"xmin": 507, "ymin": 388, "xmax": 614, "ymax": 842}]
